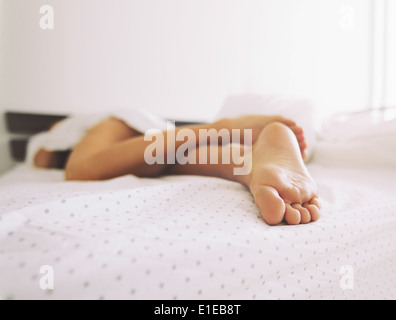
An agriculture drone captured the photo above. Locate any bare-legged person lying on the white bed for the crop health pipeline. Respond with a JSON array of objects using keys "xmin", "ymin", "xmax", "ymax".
[{"xmin": 34, "ymin": 115, "xmax": 320, "ymax": 225}]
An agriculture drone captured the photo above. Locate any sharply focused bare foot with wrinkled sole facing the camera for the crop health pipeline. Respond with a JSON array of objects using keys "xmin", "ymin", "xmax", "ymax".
[{"xmin": 245, "ymin": 122, "xmax": 320, "ymax": 225}]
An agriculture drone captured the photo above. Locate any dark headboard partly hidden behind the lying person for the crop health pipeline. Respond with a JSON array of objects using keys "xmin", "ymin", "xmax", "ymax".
[{"xmin": 5, "ymin": 112, "xmax": 203, "ymax": 162}]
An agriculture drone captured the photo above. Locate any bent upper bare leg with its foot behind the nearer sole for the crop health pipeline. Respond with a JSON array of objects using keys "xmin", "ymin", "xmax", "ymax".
[{"xmin": 65, "ymin": 116, "xmax": 305, "ymax": 180}]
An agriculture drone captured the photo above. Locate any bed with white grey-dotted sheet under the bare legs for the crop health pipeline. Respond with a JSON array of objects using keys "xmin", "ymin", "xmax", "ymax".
[{"xmin": 0, "ymin": 108, "xmax": 396, "ymax": 300}]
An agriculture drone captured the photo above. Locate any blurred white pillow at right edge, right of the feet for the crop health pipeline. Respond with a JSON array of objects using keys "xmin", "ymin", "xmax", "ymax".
[{"xmin": 314, "ymin": 113, "xmax": 396, "ymax": 169}]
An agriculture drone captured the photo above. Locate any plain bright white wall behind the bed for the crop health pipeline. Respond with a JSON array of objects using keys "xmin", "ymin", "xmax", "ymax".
[{"xmin": 3, "ymin": 0, "xmax": 371, "ymax": 120}]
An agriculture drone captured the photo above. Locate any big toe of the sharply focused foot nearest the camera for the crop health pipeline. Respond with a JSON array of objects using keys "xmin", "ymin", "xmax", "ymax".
[{"xmin": 253, "ymin": 186, "xmax": 285, "ymax": 225}]
